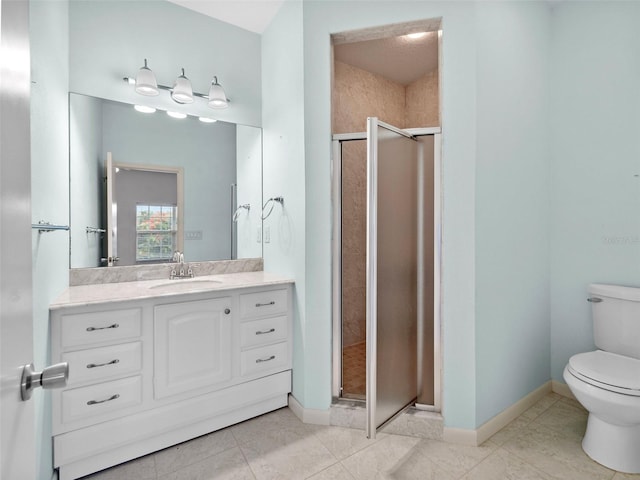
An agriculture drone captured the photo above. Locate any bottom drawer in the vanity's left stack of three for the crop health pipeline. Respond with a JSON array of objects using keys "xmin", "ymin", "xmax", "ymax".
[{"xmin": 62, "ymin": 376, "xmax": 142, "ymax": 423}]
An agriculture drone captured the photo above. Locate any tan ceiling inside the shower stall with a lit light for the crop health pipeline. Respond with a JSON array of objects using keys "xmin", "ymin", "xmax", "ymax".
[{"xmin": 334, "ymin": 32, "xmax": 438, "ymax": 86}]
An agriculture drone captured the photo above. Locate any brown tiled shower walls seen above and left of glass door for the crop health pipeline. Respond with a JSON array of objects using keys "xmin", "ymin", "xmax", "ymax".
[{"xmin": 332, "ymin": 61, "xmax": 440, "ymax": 395}]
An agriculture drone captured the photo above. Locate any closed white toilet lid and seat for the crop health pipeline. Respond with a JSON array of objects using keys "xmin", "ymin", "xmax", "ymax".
[{"xmin": 568, "ymin": 350, "xmax": 640, "ymax": 397}]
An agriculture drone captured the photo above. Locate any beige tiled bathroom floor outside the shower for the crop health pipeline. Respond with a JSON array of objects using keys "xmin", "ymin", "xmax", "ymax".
[{"xmin": 77, "ymin": 393, "xmax": 640, "ymax": 480}]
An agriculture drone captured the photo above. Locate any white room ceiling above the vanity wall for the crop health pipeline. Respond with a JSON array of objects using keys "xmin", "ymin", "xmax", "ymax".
[{"xmin": 169, "ymin": 0, "xmax": 284, "ymax": 34}]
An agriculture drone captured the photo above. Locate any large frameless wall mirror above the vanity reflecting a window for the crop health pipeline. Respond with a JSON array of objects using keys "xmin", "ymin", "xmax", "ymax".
[{"xmin": 69, "ymin": 93, "xmax": 262, "ymax": 268}]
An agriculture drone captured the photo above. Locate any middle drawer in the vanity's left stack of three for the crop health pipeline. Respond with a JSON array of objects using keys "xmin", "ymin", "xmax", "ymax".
[{"xmin": 62, "ymin": 342, "xmax": 142, "ymax": 386}]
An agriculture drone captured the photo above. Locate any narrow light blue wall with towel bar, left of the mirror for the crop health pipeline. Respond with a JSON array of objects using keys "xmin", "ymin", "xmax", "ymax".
[{"xmin": 30, "ymin": 1, "xmax": 69, "ymax": 480}]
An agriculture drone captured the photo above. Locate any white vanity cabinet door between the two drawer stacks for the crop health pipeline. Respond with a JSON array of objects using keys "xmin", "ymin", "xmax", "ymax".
[{"xmin": 154, "ymin": 297, "xmax": 233, "ymax": 398}]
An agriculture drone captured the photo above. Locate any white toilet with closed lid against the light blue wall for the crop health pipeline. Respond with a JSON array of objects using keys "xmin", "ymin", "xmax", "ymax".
[{"xmin": 563, "ymin": 285, "xmax": 640, "ymax": 473}]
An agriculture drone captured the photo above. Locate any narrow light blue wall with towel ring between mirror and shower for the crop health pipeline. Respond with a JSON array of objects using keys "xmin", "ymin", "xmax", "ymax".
[{"xmin": 262, "ymin": 2, "xmax": 308, "ymax": 408}]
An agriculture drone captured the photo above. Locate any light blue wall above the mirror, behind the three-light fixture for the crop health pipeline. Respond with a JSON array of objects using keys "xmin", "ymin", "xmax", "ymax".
[{"xmin": 69, "ymin": 0, "xmax": 261, "ymax": 125}]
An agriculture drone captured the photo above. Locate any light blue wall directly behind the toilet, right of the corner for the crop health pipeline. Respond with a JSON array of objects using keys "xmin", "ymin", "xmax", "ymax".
[{"xmin": 551, "ymin": 2, "xmax": 640, "ymax": 381}]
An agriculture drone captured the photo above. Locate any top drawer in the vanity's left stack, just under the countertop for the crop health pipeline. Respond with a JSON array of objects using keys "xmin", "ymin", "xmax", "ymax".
[{"xmin": 61, "ymin": 308, "xmax": 142, "ymax": 347}]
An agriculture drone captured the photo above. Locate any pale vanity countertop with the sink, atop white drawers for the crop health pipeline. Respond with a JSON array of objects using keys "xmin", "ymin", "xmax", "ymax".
[{"xmin": 49, "ymin": 271, "xmax": 293, "ymax": 310}]
